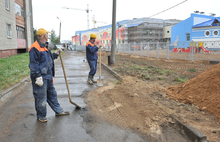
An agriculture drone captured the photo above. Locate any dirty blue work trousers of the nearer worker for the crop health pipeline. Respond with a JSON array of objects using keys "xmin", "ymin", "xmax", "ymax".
[{"xmin": 31, "ymin": 77, "xmax": 63, "ymax": 118}]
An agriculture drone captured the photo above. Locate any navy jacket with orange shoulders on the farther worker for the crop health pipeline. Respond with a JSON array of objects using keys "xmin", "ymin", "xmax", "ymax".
[{"xmin": 86, "ymin": 41, "xmax": 99, "ymax": 60}]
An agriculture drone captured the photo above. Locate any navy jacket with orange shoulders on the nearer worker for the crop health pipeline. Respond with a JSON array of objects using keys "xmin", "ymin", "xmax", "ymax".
[{"xmin": 29, "ymin": 40, "xmax": 58, "ymax": 78}]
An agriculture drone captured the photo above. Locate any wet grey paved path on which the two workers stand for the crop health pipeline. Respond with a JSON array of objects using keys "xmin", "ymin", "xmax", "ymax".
[{"xmin": 0, "ymin": 51, "xmax": 143, "ymax": 142}]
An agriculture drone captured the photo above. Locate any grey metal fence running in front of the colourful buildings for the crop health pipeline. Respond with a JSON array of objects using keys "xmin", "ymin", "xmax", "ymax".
[{"xmin": 74, "ymin": 41, "xmax": 220, "ymax": 61}]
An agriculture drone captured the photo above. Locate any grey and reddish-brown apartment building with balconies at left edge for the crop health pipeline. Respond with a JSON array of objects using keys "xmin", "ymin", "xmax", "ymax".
[{"xmin": 0, "ymin": 0, "xmax": 34, "ymax": 58}]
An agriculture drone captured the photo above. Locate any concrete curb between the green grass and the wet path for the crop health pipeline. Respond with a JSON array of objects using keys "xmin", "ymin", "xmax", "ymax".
[{"xmin": 0, "ymin": 52, "xmax": 60, "ymax": 103}]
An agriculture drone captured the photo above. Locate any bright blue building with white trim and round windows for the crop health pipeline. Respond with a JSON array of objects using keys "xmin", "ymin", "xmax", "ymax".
[{"xmin": 171, "ymin": 14, "xmax": 220, "ymax": 50}]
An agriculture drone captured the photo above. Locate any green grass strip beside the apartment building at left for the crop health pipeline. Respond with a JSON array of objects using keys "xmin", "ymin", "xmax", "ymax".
[{"xmin": 0, "ymin": 53, "xmax": 30, "ymax": 92}]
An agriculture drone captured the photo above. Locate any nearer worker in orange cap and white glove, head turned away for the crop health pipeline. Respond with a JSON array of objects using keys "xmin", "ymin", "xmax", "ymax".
[{"xmin": 29, "ymin": 28, "xmax": 70, "ymax": 122}]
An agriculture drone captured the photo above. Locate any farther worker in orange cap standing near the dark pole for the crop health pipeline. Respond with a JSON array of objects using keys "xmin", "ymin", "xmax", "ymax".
[{"xmin": 86, "ymin": 34, "xmax": 101, "ymax": 85}]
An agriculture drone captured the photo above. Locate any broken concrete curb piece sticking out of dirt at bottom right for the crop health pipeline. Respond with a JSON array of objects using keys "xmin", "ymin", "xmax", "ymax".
[{"xmin": 170, "ymin": 115, "xmax": 209, "ymax": 142}]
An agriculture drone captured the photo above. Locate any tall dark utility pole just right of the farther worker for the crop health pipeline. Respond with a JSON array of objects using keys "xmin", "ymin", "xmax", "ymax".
[{"xmin": 110, "ymin": 0, "xmax": 116, "ymax": 64}]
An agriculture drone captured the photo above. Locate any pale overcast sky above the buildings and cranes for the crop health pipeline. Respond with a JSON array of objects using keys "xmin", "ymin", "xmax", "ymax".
[{"xmin": 32, "ymin": 0, "xmax": 220, "ymax": 40}]
